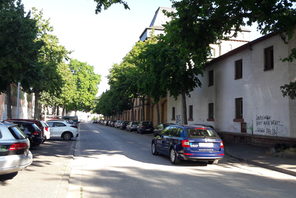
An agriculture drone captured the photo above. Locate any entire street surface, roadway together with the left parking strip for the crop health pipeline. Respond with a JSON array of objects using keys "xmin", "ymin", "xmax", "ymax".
[{"xmin": 0, "ymin": 124, "xmax": 296, "ymax": 198}]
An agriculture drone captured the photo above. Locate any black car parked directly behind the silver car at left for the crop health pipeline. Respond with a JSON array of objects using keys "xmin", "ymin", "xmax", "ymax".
[{"xmin": 7, "ymin": 119, "xmax": 44, "ymax": 146}]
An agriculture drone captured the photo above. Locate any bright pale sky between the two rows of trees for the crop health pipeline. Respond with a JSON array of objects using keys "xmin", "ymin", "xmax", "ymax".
[{"xmin": 22, "ymin": 0, "xmax": 171, "ymax": 95}]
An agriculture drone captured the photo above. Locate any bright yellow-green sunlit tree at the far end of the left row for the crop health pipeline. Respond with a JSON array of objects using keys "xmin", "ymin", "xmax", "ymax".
[{"xmin": 67, "ymin": 59, "xmax": 100, "ymax": 112}]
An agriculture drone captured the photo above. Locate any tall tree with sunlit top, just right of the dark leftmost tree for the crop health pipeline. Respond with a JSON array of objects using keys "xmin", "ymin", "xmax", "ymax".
[{"xmin": 22, "ymin": 9, "xmax": 69, "ymax": 119}]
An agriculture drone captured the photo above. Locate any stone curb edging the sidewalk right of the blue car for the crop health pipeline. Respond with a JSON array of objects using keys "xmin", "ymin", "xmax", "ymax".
[{"xmin": 225, "ymin": 152, "xmax": 296, "ymax": 177}]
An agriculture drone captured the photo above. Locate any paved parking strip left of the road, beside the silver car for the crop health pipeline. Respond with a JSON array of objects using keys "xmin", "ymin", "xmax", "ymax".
[{"xmin": 0, "ymin": 137, "xmax": 76, "ymax": 198}]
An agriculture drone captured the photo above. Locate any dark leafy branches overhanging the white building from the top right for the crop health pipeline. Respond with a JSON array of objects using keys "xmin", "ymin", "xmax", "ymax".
[{"xmin": 168, "ymin": 0, "xmax": 296, "ymax": 99}]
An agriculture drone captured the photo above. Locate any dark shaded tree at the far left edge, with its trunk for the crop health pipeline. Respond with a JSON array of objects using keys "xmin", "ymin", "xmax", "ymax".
[{"xmin": 0, "ymin": 0, "xmax": 42, "ymax": 118}]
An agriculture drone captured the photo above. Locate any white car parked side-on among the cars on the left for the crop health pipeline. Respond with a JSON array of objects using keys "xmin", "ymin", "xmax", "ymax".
[{"xmin": 47, "ymin": 120, "xmax": 79, "ymax": 140}]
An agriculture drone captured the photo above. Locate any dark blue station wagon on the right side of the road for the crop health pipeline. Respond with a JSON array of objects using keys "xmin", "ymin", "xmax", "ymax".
[{"xmin": 151, "ymin": 125, "xmax": 224, "ymax": 164}]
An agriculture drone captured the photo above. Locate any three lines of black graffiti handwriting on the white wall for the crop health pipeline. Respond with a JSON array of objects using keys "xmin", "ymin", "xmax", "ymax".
[{"xmin": 254, "ymin": 115, "xmax": 286, "ymax": 136}]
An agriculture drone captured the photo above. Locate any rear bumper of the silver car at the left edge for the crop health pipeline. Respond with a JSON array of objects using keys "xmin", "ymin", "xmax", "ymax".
[{"xmin": 0, "ymin": 151, "xmax": 33, "ymax": 175}]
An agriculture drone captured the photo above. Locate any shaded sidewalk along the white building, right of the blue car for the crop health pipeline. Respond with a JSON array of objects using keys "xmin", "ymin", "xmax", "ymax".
[{"xmin": 225, "ymin": 144, "xmax": 296, "ymax": 177}]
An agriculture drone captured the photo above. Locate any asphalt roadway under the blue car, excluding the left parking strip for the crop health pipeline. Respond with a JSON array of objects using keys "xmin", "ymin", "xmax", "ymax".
[{"xmin": 67, "ymin": 124, "xmax": 296, "ymax": 198}]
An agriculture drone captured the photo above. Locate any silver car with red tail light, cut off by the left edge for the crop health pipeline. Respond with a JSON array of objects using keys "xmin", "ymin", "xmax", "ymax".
[{"xmin": 0, "ymin": 122, "xmax": 33, "ymax": 180}]
